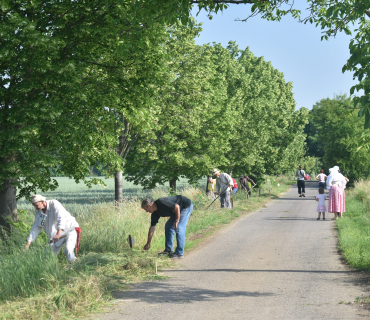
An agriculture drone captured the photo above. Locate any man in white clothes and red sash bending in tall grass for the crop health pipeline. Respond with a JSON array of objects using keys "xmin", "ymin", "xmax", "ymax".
[{"xmin": 26, "ymin": 194, "xmax": 81, "ymax": 262}]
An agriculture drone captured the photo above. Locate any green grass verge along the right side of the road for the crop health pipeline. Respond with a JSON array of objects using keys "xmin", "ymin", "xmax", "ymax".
[{"xmin": 337, "ymin": 181, "xmax": 370, "ymax": 271}]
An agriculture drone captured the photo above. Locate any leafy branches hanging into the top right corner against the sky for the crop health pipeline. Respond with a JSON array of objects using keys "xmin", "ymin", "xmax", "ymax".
[{"xmin": 191, "ymin": 0, "xmax": 370, "ymax": 129}]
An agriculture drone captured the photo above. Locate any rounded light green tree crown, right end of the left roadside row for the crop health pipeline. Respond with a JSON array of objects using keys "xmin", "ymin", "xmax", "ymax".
[{"xmin": 214, "ymin": 42, "xmax": 305, "ymax": 179}]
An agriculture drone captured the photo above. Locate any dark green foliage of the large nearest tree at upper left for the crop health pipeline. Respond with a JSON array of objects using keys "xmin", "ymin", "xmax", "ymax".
[{"xmin": 0, "ymin": 0, "xmax": 188, "ymax": 225}]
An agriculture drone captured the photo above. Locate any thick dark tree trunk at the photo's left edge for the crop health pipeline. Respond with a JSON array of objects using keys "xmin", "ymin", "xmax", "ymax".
[{"xmin": 0, "ymin": 179, "xmax": 18, "ymax": 229}]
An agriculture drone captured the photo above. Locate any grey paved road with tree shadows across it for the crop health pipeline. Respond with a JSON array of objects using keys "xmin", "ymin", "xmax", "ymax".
[{"xmin": 94, "ymin": 182, "xmax": 370, "ymax": 320}]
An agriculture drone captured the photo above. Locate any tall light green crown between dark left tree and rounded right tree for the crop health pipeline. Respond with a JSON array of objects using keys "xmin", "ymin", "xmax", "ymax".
[{"xmin": 125, "ymin": 27, "xmax": 232, "ymax": 190}]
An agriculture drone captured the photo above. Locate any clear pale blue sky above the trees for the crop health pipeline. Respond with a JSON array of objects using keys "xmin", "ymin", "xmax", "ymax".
[{"xmin": 192, "ymin": 3, "xmax": 356, "ymax": 109}]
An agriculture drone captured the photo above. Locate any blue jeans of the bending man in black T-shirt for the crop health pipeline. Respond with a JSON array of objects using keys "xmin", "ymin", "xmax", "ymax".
[{"xmin": 164, "ymin": 203, "xmax": 193, "ymax": 256}]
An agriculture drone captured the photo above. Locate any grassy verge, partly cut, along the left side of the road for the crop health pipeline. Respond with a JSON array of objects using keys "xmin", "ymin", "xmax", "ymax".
[{"xmin": 0, "ymin": 178, "xmax": 291, "ymax": 320}]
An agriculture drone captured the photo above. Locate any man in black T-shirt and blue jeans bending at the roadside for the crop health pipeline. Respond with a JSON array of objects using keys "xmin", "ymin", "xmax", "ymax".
[{"xmin": 141, "ymin": 195, "xmax": 193, "ymax": 259}]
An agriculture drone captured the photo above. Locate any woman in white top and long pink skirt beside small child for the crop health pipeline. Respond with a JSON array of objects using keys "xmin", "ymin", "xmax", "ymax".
[{"xmin": 326, "ymin": 166, "xmax": 348, "ymax": 219}]
